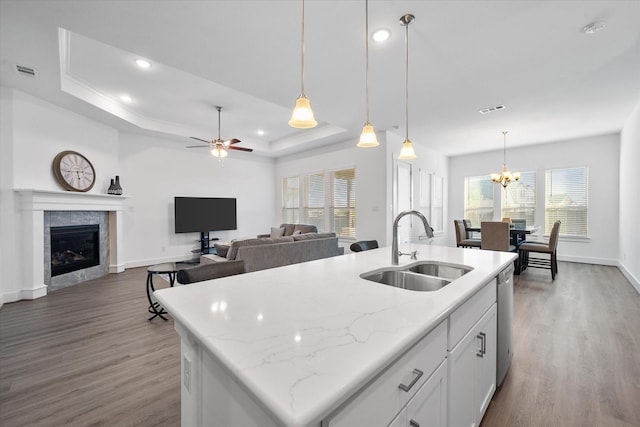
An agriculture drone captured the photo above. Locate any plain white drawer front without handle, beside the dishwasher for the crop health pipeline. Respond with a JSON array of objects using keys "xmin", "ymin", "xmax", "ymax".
[{"xmin": 448, "ymin": 279, "xmax": 497, "ymax": 350}]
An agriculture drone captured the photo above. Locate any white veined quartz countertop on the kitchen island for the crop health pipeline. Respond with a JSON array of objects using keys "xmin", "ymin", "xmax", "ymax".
[{"xmin": 155, "ymin": 245, "xmax": 516, "ymax": 426}]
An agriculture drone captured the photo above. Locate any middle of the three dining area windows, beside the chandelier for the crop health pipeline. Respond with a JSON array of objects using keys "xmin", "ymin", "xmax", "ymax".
[{"xmin": 502, "ymin": 172, "xmax": 536, "ymax": 225}]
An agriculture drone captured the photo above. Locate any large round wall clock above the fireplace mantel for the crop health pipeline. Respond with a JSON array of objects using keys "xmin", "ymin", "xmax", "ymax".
[{"xmin": 53, "ymin": 151, "xmax": 96, "ymax": 191}]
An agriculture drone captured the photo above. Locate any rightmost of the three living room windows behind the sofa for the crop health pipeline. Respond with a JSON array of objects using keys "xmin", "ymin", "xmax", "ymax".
[{"xmin": 331, "ymin": 169, "xmax": 356, "ymax": 238}]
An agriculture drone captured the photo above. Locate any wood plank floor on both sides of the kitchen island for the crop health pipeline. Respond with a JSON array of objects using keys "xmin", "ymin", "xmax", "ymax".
[{"xmin": 0, "ymin": 263, "xmax": 640, "ymax": 427}]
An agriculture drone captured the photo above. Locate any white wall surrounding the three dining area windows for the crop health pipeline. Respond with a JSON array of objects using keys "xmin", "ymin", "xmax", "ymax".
[{"xmin": 448, "ymin": 134, "xmax": 620, "ymax": 265}]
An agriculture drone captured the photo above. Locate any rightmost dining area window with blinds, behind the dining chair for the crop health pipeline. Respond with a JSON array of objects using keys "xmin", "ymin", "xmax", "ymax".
[{"xmin": 544, "ymin": 167, "xmax": 589, "ymax": 237}]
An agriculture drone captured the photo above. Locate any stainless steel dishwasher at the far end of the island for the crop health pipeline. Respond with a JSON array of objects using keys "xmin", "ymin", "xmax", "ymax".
[{"xmin": 496, "ymin": 264, "xmax": 513, "ymax": 386}]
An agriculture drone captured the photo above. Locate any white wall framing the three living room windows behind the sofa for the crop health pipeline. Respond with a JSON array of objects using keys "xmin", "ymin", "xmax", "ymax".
[{"xmin": 274, "ymin": 134, "xmax": 386, "ymax": 246}]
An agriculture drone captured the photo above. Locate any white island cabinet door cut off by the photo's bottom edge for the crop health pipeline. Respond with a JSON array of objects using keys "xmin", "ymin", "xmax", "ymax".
[{"xmin": 389, "ymin": 360, "xmax": 447, "ymax": 427}]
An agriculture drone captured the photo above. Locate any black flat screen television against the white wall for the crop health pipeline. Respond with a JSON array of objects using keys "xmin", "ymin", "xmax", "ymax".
[{"xmin": 174, "ymin": 197, "xmax": 237, "ymax": 233}]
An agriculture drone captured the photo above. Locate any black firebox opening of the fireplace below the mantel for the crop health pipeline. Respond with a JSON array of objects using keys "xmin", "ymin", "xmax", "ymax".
[{"xmin": 51, "ymin": 224, "xmax": 100, "ymax": 277}]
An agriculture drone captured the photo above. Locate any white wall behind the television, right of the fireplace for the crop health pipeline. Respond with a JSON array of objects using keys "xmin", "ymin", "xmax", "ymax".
[{"xmin": 119, "ymin": 132, "xmax": 275, "ymax": 267}]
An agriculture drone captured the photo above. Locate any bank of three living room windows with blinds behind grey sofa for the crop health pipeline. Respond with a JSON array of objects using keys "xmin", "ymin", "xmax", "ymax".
[{"xmin": 282, "ymin": 168, "xmax": 356, "ymax": 238}]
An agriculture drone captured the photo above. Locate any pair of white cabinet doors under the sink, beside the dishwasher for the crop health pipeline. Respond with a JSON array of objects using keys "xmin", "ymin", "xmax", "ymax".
[{"xmin": 447, "ymin": 304, "xmax": 497, "ymax": 427}]
